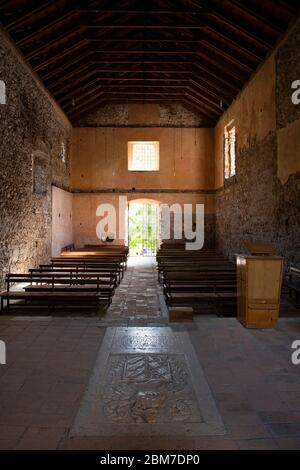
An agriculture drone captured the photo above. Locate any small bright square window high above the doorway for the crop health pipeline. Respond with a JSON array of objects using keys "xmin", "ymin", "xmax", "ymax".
[{"xmin": 128, "ymin": 142, "xmax": 159, "ymax": 171}]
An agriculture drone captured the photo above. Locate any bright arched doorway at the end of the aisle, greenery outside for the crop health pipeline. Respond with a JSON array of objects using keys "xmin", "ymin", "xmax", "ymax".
[{"xmin": 128, "ymin": 199, "xmax": 159, "ymax": 256}]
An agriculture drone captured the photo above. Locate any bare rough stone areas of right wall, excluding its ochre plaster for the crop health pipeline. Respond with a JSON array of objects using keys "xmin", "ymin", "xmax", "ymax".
[{"xmin": 216, "ymin": 25, "xmax": 300, "ymax": 267}]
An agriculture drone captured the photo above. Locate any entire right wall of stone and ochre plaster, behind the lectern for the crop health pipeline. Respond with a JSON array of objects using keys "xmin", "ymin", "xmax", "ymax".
[{"xmin": 215, "ymin": 20, "xmax": 300, "ymax": 267}]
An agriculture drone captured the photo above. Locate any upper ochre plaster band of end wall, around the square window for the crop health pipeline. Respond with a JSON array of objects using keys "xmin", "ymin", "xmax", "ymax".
[{"xmin": 71, "ymin": 128, "xmax": 214, "ymax": 191}]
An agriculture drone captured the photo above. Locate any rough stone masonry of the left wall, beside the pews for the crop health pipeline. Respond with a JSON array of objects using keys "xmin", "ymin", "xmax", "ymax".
[{"xmin": 0, "ymin": 30, "xmax": 72, "ymax": 287}]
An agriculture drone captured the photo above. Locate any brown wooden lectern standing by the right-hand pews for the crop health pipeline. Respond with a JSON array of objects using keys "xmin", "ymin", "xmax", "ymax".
[{"xmin": 237, "ymin": 242, "xmax": 283, "ymax": 328}]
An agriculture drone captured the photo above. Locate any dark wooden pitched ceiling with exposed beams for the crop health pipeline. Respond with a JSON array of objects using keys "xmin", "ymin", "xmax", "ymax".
[{"xmin": 0, "ymin": 0, "xmax": 299, "ymax": 125}]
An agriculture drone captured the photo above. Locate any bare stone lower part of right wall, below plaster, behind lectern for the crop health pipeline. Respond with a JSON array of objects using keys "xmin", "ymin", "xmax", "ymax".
[{"xmin": 216, "ymin": 132, "xmax": 278, "ymax": 256}]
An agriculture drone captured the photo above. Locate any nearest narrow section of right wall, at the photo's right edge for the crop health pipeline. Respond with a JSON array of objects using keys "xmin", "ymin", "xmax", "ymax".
[{"xmin": 275, "ymin": 21, "xmax": 300, "ymax": 267}]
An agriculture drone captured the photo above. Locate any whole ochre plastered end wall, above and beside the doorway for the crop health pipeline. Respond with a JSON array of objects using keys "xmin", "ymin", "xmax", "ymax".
[{"xmin": 71, "ymin": 124, "xmax": 215, "ymax": 250}]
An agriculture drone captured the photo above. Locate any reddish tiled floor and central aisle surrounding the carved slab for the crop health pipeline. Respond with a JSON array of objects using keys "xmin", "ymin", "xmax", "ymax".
[{"xmin": 0, "ymin": 260, "xmax": 300, "ymax": 449}]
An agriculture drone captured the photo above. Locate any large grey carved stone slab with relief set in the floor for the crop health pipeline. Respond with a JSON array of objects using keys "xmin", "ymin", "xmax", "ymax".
[{"xmin": 71, "ymin": 327, "xmax": 225, "ymax": 437}]
